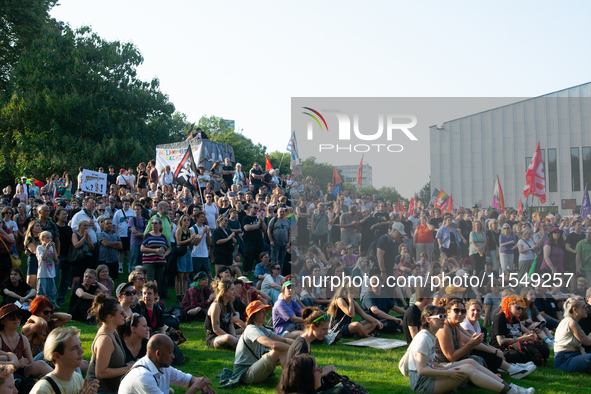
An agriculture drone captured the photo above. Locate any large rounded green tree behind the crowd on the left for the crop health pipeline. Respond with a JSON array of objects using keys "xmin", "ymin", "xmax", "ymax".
[{"xmin": 0, "ymin": 20, "xmax": 183, "ymax": 185}]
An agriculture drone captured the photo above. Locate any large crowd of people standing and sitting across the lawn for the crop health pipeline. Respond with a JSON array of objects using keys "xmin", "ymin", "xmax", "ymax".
[{"xmin": 0, "ymin": 152, "xmax": 591, "ymax": 394}]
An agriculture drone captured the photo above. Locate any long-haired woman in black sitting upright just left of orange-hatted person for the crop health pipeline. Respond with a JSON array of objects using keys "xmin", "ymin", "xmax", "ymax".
[{"xmin": 203, "ymin": 279, "xmax": 238, "ymax": 349}]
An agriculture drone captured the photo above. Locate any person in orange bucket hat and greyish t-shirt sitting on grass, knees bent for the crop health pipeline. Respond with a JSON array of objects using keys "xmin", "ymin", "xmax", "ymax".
[{"xmin": 219, "ymin": 300, "xmax": 293, "ymax": 388}]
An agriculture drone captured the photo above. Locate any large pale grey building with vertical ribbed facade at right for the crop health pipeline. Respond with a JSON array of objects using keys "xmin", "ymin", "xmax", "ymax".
[{"xmin": 430, "ymin": 83, "xmax": 591, "ymax": 215}]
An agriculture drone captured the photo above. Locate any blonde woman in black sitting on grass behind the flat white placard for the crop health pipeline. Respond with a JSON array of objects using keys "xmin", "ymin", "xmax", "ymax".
[{"xmin": 328, "ymin": 280, "xmax": 384, "ymax": 338}]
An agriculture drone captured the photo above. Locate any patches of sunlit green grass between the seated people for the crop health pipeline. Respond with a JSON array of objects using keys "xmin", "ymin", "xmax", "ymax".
[{"xmin": 30, "ymin": 260, "xmax": 591, "ymax": 394}]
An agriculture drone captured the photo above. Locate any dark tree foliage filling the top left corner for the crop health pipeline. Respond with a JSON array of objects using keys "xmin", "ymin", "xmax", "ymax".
[{"xmin": 0, "ymin": 0, "xmax": 57, "ymax": 98}]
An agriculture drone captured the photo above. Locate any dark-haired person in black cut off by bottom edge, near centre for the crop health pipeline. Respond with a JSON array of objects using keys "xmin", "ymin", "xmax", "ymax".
[{"xmin": 277, "ymin": 354, "xmax": 349, "ymax": 394}]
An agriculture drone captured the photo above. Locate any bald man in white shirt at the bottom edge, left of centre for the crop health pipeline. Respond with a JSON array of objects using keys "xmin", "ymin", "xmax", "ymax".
[{"xmin": 119, "ymin": 334, "xmax": 216, "ymax": 394}]
